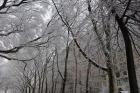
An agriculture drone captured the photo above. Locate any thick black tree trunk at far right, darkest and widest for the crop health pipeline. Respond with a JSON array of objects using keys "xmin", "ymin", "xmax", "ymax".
[{"xmin": 115, "ymin": 14, "xmax": 139, "ymax": 93}]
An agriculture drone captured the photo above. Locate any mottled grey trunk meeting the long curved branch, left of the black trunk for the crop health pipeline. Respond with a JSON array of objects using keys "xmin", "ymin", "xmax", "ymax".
[{"xmin": 102, "ymin": 16, "xmax": 115, "ymax": 93}]
